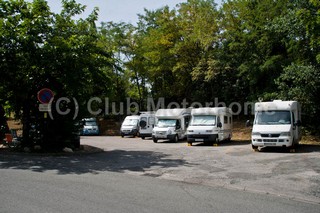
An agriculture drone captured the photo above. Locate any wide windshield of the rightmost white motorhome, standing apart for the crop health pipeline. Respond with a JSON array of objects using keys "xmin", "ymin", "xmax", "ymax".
[{"xmin": 254, "ymin": 111, "xmax": 291, "ymax": 125}]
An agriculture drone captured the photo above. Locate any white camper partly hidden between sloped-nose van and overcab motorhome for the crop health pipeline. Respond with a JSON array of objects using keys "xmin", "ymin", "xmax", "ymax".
[{"xmin": 139, "ymin": 112, "xmax": 156, "ymax": 139}]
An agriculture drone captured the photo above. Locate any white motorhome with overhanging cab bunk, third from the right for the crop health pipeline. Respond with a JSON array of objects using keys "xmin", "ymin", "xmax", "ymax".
[{"xmin": 152, "ymin": 108, "xmax": 191, "ymax": 143}]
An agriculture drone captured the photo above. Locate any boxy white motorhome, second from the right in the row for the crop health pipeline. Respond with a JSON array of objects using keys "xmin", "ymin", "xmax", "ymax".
[{"xmin": 187, "ymin": 107, "xmax": 233, "ymax": 146}]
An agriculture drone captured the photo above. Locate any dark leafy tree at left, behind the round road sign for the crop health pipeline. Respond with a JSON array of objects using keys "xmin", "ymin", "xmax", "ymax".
[{"xmin": 0, "ymin": 0, "xmax": 112, "ymax": 148}]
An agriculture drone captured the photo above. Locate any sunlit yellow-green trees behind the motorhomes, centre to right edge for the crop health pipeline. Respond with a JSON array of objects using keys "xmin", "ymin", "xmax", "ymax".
[{"xmin": 129, "ymin": 0, "xmax": 320, "ymax": 128}]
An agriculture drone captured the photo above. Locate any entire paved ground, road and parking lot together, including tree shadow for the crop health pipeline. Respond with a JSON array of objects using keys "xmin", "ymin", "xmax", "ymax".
[{"xmin": 0, "ymin": 137, "xmax": 320, "ymax": 213}]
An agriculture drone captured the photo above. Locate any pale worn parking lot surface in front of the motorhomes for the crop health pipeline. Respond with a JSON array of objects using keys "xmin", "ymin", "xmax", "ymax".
[{"xmin": 81, "ymin": 136, "xmax": 320, "ymax": 204}]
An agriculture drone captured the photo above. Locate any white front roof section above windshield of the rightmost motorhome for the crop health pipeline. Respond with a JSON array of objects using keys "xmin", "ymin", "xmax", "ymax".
[{"xmin": 255, "ymin": 100, "xmax": 298, "ymax": 111}]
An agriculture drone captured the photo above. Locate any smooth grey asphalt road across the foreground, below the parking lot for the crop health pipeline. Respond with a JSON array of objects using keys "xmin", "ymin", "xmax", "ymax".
[{"xmin": 0, "ymin": 167, "xmax": 320, "ymax": 213}]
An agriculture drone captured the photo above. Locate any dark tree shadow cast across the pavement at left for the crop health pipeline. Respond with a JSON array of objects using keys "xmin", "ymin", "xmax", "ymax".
[{"xmin": 0, "ymin": 150, "xmax": 189, "ymax": 175}]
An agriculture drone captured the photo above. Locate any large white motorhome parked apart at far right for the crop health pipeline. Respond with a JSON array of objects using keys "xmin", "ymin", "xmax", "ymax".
[{"xmin": 251, "ymin": 100, "xmax": 301, "ymax": 151}]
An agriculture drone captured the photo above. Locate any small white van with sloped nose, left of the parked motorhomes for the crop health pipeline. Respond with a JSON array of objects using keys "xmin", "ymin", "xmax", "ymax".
[{"xmin": 120, "ymin": 115, "xmax": 140, "ymax": 137}]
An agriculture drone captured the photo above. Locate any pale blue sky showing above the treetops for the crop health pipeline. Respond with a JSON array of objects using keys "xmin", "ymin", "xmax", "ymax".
[{"xmin": 47, "ymin": 0, "xmax": 221, "ymax": 24}]
